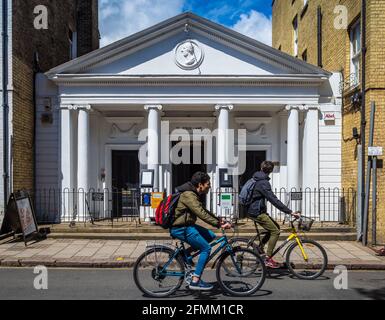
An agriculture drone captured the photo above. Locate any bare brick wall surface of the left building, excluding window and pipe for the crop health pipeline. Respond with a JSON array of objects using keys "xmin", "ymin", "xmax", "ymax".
[{"xmin": 12, "ymin": 0, "xmax": 99, "ymax": 191}]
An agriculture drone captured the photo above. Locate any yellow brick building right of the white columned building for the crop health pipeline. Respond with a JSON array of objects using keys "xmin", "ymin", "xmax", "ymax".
[{"xmin": 272, "ymin": 0, "xmax": 385, "ymax": 243}]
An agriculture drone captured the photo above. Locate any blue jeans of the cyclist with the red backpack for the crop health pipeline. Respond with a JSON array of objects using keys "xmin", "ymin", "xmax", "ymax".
[{"xmin": 170, "ymin": 225, "xmax": 216, "ymax": 277}]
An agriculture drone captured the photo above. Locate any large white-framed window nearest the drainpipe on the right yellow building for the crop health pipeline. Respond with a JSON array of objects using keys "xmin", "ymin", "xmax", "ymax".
[{"xmin": 350, "ymin": 21, "xmax": 361, "ymax": 86}]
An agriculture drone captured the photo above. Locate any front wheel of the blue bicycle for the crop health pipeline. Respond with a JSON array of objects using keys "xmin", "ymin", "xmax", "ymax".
[{"xmin": 216, "ymin": 247, "xmax": 266, "ymax": 297}]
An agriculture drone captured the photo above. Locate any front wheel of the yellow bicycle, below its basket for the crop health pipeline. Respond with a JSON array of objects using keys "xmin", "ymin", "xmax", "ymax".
[{"xmin": 286, "ymin": 239, "xmax": 328, "ymax": 280}]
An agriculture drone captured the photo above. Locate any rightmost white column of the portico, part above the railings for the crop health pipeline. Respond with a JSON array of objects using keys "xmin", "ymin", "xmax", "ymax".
[{"xmin": 302, "ymin": 106, "xmax": 319, "ymax": 190}]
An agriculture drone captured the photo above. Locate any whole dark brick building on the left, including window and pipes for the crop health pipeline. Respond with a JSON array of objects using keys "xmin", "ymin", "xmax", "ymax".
[{"xmin": 0, "ymin": 0, "xmax": 99, "ymax": 218}]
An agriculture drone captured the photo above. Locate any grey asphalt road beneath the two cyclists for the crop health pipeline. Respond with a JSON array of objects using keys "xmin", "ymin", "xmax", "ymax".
[{"xmin": 0, "ymin": 268, "xmax": 385, "ymax": 301}]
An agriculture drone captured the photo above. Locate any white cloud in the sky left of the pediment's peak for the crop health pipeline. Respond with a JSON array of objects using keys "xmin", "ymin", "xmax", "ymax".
[{"xmin": 99, "ymin": 0, "xmax": 184, "ymax": 47}]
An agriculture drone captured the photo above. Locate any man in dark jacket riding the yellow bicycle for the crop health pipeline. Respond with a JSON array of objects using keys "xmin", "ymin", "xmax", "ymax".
[{"xmin": 247, "ymin": 161, "xmax": 301, "ymax": 269}]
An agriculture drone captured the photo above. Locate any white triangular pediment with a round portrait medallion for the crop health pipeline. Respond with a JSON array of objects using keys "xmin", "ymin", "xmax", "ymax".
[{"xmin": 47, "ymin": 13, "xmax": 329, "ymax": 78}]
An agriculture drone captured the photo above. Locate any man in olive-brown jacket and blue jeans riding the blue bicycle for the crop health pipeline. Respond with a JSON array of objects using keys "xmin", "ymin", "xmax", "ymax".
[{"xmin": 170, "ymin": 172, "xmax": 231, "ymax": 290}]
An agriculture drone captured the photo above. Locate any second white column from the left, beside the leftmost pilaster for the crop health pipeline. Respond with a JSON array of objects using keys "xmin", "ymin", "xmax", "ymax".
[{"xmin": 77, "ymin": 105, "xmax": 91, "ymax": 221}]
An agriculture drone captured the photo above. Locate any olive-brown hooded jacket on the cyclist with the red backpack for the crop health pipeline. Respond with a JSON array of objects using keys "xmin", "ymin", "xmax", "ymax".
[{"xmin": 172, "ymin": 182, "xmax": 220, "ymax": 228}]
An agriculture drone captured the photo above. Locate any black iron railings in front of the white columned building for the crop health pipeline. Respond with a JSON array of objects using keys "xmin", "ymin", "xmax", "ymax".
[{"xmin": 30, "ymin": 188, "xmax": 357, "ymax": 224}]
